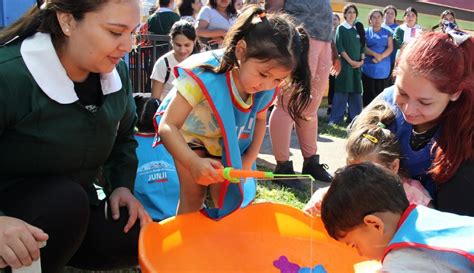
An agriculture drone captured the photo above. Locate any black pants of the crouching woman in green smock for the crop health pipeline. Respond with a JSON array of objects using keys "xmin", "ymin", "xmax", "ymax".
[{"xmin": 0, "ymin": 177, "xmax": 140, "ymax": 273}]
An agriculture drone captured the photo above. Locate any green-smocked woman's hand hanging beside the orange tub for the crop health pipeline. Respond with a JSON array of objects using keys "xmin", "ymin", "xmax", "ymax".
[{"xmin": 109, "ymin": 187, "xmax": 152, "ymax": 233}]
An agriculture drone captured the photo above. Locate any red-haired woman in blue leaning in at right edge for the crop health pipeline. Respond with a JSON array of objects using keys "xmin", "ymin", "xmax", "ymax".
[{"xmin": 382, "ymin": 33, "xmax": 474, "ymax": 216}]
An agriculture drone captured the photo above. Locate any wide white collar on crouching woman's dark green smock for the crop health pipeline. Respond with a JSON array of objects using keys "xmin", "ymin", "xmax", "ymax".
[{"xmin": 20, "ymin": 32, "xmax": 122, "ymax": 104}]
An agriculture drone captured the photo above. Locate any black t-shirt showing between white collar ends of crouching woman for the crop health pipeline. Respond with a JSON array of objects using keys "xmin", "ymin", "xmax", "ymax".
[{"xmin": 74, "ymin": 73, "xmax": 103, "ymax": 112}]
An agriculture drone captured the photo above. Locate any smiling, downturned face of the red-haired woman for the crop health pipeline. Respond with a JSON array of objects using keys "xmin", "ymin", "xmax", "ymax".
[{"xmin": 395, "ymin": 60, "xmax": 460, "ymax": 132}]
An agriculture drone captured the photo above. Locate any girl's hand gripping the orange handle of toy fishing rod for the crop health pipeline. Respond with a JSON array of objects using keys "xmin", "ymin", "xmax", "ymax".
[{"xmin": 190, "ymin": 157, "xmax": 224, "ymax": 186}]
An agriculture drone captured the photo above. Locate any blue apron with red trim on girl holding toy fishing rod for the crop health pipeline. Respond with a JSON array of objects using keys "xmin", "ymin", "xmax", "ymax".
[{"xmin": 155, "ymin": 50, "xmax": 276, "ymax": 219}]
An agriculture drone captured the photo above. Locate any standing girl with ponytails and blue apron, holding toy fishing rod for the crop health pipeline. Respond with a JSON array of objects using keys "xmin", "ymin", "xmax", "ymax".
[{"xmin": 158, "ymin": 5, "xmax": 311, "ymax": 214}]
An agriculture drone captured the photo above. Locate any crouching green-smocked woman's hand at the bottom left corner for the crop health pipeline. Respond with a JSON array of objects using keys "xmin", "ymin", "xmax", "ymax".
[{"xmin": 0, "ymin": 216, "xmax": 48, "ymax": 268}]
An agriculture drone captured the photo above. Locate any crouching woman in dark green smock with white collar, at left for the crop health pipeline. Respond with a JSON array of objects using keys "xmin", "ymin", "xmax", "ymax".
[{"xmin": 0, "ymin": 0, "xmax": 150, "ymax": 272}]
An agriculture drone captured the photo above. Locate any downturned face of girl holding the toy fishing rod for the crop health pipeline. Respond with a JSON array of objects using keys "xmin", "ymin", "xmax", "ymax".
[{"xmin": 238, "ymin": 58, "xmax": 291, "ymax": 94}]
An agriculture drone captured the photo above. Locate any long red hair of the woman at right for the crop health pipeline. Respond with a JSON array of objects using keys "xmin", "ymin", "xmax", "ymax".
[{"xmin": 395, "ymin": 32, "xmax": 474, "ymax": 183}]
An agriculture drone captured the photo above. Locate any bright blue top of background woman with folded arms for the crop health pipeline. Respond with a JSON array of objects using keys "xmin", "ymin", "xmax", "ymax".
[{"xmin": 362, "ymin": 27, "xmax": 392, "ymax": 79}]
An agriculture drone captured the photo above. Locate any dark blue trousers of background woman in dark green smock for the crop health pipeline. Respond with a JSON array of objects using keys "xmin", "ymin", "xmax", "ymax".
[{"xmin": 329, "ymin": 92, "xmax": 362, "ymax": 123}]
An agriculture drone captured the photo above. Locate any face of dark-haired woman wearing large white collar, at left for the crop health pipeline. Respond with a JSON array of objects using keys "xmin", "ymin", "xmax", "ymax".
[{"xmin": 58, "ymin": 0, "xmax": 140, "ymax": 80}]
